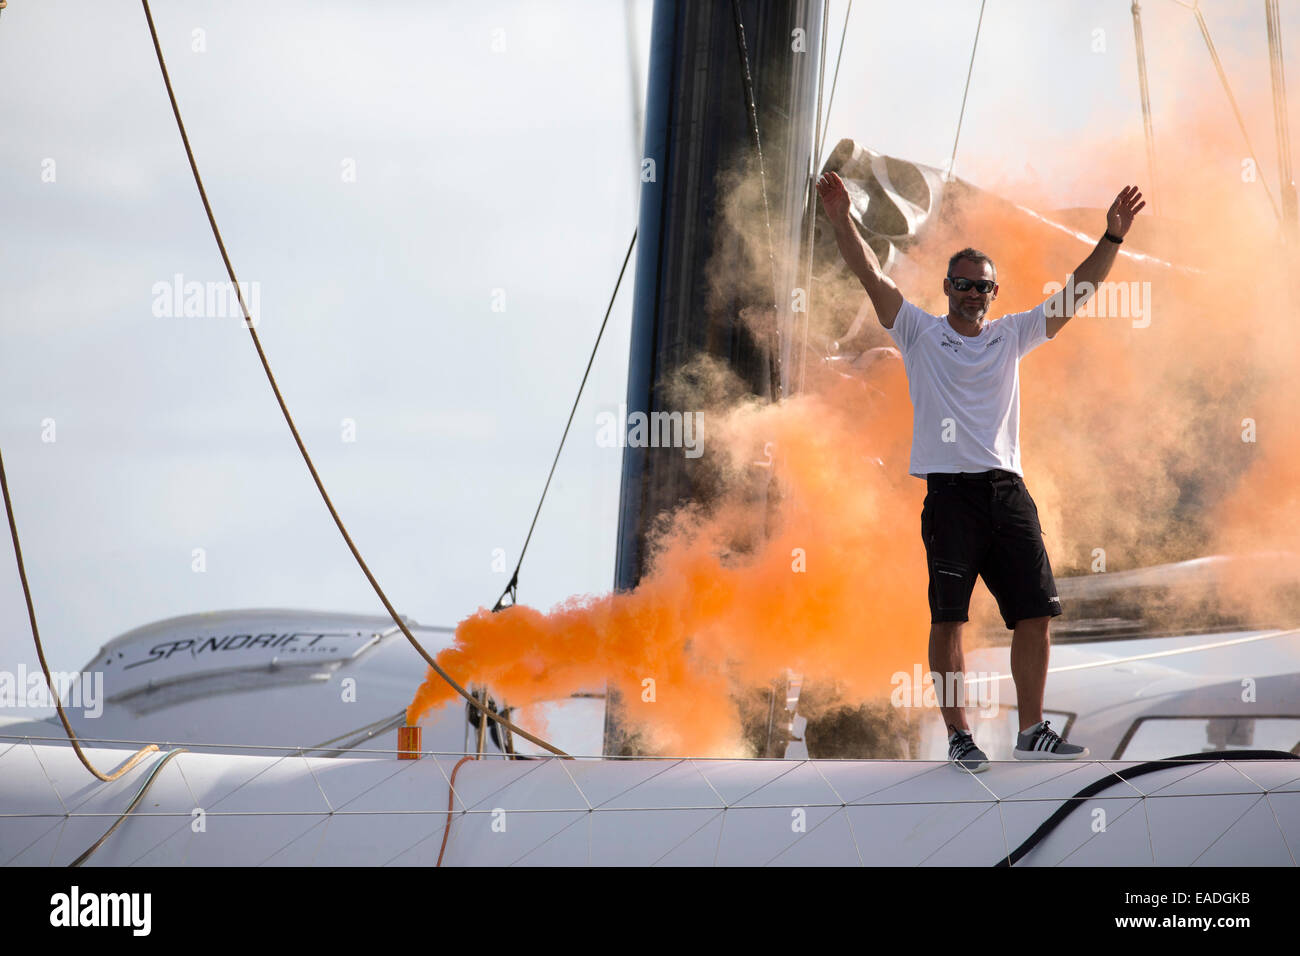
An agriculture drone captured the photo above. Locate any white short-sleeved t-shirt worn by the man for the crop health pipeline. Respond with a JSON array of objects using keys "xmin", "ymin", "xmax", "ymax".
[{"xmin": 889, "ymin": 300, "xmax": 1048, "ymax": 477}]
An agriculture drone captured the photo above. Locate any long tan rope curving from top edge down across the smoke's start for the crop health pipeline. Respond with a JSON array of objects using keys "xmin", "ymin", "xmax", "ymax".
[{"xmin": 140, "ymin": 0, "xmax": 568, "ymax": 757}]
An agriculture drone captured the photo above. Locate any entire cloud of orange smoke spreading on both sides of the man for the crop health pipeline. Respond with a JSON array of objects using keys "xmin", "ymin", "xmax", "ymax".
[{"xmin": 407, "ymin": 98, "xmax": 1300, "ymax": 756}]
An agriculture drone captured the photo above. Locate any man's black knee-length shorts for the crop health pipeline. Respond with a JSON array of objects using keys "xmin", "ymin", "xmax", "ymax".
[{"xmin": 920, "ymin": 470, "xmax": 1061, "ymax": 630}]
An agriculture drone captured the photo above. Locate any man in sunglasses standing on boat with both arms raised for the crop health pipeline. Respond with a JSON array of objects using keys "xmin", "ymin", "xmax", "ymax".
[{"xmin": 818, "ymin": 173, "xmax": 1145, "ymax": 773}]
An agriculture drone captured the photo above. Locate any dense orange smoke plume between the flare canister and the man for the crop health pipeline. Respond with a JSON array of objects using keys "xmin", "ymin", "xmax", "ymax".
[{"xmin": 407, "ymin": 360, "xmax": 927, "ymax": 754}]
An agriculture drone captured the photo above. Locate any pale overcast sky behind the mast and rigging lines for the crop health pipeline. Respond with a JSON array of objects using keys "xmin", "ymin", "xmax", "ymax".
[{"xmin": 0, "ymin": 0, "xmax": 1300, "ymax": 688}]
